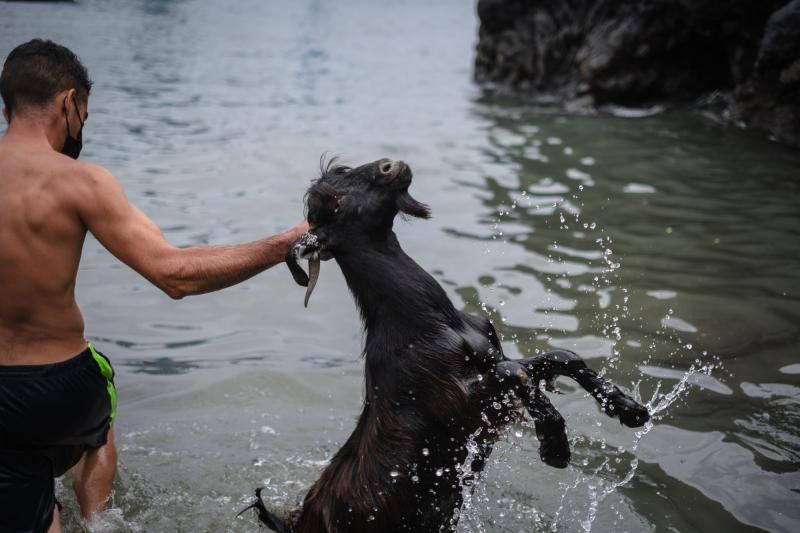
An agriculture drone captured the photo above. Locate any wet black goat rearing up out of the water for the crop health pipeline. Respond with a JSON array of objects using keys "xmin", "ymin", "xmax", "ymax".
[{"xmin": 245, "ymin": 159, "xmax": 649, "ymax": 533}]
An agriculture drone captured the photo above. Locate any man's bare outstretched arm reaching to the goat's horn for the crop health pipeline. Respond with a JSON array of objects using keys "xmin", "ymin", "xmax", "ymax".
[{"xmin": 76, "ymin": 165, "xmax": 308, "ymax": 299}]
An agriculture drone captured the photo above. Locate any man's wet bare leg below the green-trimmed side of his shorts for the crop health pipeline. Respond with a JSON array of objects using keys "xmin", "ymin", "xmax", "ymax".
[{"xmin": 71, "ymin": 427, "xmax": 117, "ymax": 520}]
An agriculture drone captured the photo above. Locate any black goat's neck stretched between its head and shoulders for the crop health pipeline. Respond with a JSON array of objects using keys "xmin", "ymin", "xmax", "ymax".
[{"xmin": 336, "ymin": 232, "xmax": 456, "ymax": 342}]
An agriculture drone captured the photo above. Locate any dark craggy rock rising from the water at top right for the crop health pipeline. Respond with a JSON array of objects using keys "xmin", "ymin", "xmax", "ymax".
[{"xmin": 475, "ymin": 0, "xmax": 800, "ymax": 146}]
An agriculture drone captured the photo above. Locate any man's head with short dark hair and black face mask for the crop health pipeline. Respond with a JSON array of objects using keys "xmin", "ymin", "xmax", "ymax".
[{"xmin": 0, "ymin": 39, "xmax": 92, "ymax": 157}]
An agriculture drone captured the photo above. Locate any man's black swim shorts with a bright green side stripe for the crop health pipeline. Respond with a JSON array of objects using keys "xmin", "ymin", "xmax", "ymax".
[{"xmin": 0, "ymin": 344, "xmax": 117, "ymax": 533}]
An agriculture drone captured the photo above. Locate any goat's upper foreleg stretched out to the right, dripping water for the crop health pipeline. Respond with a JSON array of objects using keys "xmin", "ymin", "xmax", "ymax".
[{"xmin": 519, "ymin": 350, "xmax": 650, "ymax": 428}]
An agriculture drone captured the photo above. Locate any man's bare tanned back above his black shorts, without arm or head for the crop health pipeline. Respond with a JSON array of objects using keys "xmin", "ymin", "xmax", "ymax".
[{"xmin": 0, "ymin": 138, "xmax": 87, "ymax": 365}]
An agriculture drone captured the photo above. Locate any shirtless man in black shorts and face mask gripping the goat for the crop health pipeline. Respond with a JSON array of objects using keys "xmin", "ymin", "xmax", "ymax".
[{"xmin": 0, "ymin": 39, "xmax": 307, "ymax": 533}]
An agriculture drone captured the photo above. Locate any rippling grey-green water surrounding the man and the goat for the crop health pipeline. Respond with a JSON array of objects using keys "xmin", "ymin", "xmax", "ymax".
[{"xmin": 0, "ymin": 0, "xmax": 800, "ymax": 533}]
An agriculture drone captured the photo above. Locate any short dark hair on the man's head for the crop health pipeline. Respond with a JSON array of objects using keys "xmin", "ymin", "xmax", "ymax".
[{"xmin": 0, "ymin": 39, "xmax": 92, "ymax": 118}]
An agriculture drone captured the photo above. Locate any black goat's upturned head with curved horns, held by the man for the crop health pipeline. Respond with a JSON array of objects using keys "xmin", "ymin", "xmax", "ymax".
[{"xmin": 286, "ymin": 159, "xmax": 430, "ymax": 306}]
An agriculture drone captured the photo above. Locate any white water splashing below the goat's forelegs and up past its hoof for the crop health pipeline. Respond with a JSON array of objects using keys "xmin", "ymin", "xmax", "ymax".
[{"xmin": 455, "ymin": 362, "xmax": 717, "ymax": 533}]
